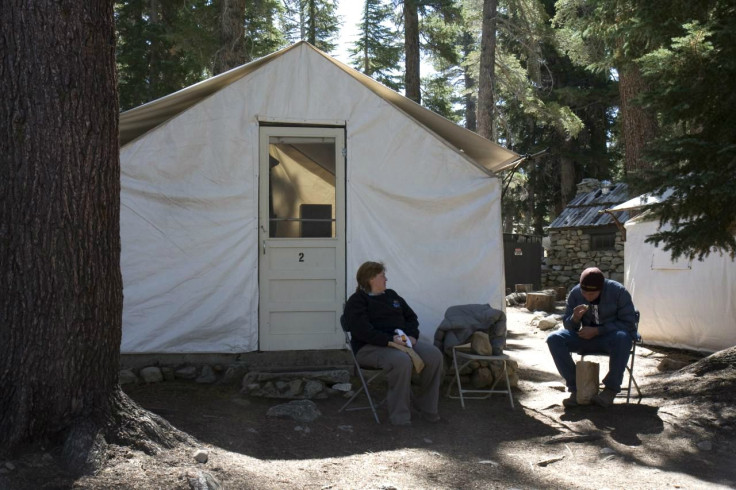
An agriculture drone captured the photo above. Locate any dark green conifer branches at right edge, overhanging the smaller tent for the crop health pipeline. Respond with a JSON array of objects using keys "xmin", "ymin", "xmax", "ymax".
[{"xmin": 634, "ymin": 0, "xmax": 736, "ymax": 259}]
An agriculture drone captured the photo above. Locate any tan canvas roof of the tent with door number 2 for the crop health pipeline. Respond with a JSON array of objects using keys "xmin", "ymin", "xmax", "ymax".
[{"xmin": 120, "ymin": 41, "xmax": 520, "ymax": 172}]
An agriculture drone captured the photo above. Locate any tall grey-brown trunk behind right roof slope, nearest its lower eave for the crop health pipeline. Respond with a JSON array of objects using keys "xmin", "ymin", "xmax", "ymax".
[{"xmin": 478, "ymin": 0, "xmax": 498, "ymax": 141}]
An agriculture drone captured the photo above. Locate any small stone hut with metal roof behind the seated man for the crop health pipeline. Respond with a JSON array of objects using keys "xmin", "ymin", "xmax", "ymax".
[{"xmin": 542, "ymin": 179, "xmax": 629, "ymax": 289}]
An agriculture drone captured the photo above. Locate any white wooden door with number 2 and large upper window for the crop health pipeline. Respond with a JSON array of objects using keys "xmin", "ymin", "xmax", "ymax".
[{"xmin": 258, "ymin": 126, "xmax": 345, "ymax": 351}]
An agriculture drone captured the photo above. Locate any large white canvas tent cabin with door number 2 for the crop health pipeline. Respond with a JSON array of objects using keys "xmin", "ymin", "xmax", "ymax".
[{"xmin": 120, "ymin": 42, "xmax": 518, "ymax": 354}]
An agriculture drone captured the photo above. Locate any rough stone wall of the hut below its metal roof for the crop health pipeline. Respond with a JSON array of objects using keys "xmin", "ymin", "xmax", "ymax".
[{"xmin": 542, "ymin": 228, "xmax": 624, "ymax": 290}]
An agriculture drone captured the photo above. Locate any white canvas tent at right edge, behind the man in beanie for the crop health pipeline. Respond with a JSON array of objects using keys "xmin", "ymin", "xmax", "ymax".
[{"xmin": 613, "ymin": 195, "xmax": 736, "ymax": 352}]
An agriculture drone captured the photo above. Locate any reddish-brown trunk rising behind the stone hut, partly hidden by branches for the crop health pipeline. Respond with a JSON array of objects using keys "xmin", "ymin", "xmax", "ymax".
[{"xmin": 618, "ymin": 63, "xmax": 657, "ymax": 173}]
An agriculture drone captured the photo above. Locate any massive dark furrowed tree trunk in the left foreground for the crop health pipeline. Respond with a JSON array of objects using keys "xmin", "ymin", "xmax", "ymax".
[{"xmin": 0, "ymin": 0, "xmax": 190, "ymax": 470}]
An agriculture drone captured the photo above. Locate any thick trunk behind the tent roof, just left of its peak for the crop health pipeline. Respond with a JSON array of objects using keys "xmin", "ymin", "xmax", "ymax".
[{"xmin": 213, "ymin": 0, "xmax": 247, "ymax": 75}]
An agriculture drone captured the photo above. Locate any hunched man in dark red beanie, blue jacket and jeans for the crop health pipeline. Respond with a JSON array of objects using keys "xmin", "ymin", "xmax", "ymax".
[{"xmin": 547, "ymin": 267, "xmax": 636, "ymax": 408}]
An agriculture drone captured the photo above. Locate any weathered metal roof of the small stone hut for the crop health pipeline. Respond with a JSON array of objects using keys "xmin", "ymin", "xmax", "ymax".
[{"xmin": 549, "ymin": 183, "xmax": 629, "ymax": 229}]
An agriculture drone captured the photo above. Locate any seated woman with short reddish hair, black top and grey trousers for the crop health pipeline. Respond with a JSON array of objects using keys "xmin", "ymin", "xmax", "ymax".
[{"xmin": 345, "ymin": 262, "xmax": 443, "ymax": 425}]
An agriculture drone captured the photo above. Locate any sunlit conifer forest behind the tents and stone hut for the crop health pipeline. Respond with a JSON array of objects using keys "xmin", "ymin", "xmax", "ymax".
[{"xmin": 115, "ymin": 0, "xmax": 736, "ymax": 258}]
